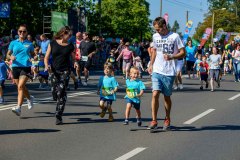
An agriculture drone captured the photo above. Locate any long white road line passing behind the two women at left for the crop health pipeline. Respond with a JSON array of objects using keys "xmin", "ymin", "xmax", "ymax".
[{"xmin": 0, "ymin": 92, "xmax": 95, "ymax": 111}]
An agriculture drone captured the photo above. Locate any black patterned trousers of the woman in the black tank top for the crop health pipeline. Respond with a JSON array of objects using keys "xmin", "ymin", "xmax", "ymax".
[{"xmin": 51, "ymin": 71, "xmax": 70, "ymax": 117}]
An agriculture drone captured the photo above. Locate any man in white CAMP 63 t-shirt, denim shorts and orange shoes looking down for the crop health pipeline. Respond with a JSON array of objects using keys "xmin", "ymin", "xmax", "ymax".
[{"xmin": 148, "ymin": 17, "xmax": 186, "ymax": 130}]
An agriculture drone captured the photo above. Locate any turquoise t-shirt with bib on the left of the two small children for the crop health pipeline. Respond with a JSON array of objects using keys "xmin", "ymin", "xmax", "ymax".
[{"xmin": 98, "ymin": 76, "xmax": 119, "ymax": 101}]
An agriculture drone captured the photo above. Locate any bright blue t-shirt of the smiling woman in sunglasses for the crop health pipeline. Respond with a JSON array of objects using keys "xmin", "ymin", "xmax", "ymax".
[{"xmin": 8, "ymin": 39, "xmax": 34, "ymax": 67}]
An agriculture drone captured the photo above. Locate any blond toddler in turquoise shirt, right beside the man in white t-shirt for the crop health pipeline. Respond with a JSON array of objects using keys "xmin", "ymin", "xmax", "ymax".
[{"xmin": 123, "ymin": 67, "xmax": 146, "ymax": 126}]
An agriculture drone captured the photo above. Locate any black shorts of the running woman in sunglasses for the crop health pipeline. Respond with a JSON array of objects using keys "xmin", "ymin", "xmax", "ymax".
[{"xmin": 12, "ymin": 67, "xmax": 31, "ymax": 79}]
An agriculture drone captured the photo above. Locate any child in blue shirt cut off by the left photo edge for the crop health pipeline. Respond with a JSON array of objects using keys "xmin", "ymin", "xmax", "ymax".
[{"xmin": 0, "ymin": 53, "xmax": 11, "ymax": 104}]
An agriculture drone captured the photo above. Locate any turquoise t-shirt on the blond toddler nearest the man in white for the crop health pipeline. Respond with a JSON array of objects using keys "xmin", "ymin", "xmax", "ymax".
[{"xmin": 124, "ymin": 79, "xmax": 146, "ymax": 103}]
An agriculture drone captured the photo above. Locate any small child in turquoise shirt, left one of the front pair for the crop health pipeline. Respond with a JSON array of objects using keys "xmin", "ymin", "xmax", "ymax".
[{"xmin": 97, "ymin": 63, "xmax": 118, "ymax": 122}]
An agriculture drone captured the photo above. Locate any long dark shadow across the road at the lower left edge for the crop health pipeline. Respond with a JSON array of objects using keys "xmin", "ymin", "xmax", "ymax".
[{"xmin": 0, "ymin": 129, "xmax": 61, "ymax": 135}]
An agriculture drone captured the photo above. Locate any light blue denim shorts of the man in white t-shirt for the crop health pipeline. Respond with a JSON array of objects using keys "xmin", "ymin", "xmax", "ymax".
[{"xmin": 152, "ymin": 72, "xmax": 175, "ymax": 96}]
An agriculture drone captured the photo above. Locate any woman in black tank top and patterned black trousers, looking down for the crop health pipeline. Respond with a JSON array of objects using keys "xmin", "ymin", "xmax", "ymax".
[{"xmin": 44, "ymin": 26, "xmax": 78, "ymax": 125}]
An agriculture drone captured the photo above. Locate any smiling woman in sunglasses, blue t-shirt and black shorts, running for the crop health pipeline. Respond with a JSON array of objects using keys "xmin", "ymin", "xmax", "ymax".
[{"xmin": 7, "ymin": 24, "xmax": 34, "ymax": 116}]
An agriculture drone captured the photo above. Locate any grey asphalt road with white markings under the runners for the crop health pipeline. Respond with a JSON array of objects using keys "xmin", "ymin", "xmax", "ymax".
[{"xmin": 0, "ymin": 75, "xmax": 240, "ymax": 160}]
